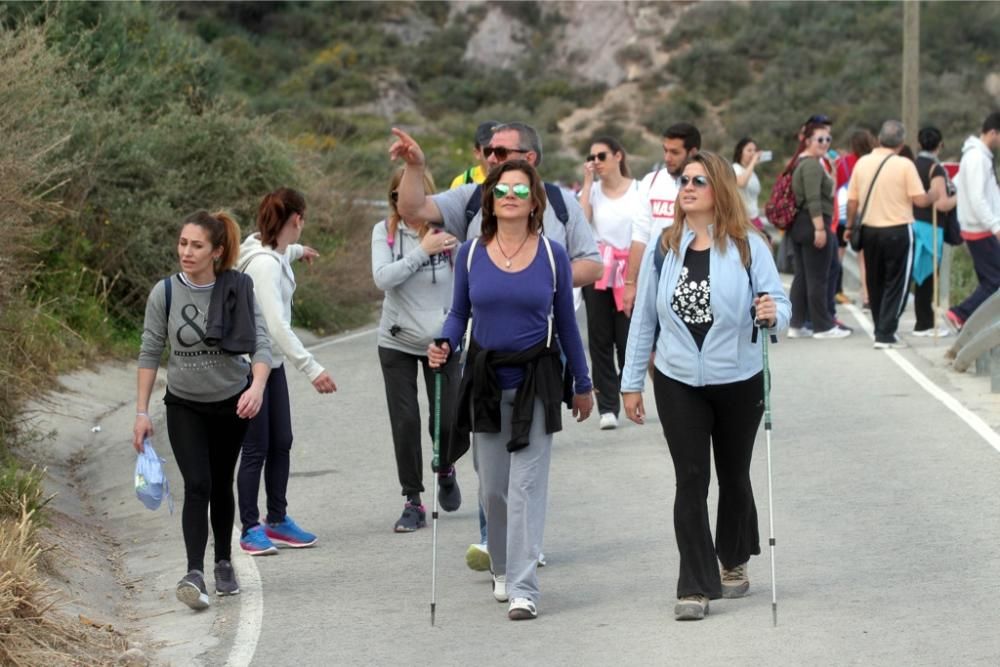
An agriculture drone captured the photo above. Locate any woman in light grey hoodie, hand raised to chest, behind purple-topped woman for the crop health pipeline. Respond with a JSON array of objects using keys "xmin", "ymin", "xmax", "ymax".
[{"xmin": 372, "ymin": 170, "xmax": 461, "ymax": 533}]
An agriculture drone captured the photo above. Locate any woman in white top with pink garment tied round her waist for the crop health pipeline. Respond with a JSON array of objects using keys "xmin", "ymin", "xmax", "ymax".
[{"xmin": 580, "ymin": 137, "xmax": 642, "ymax": 429}]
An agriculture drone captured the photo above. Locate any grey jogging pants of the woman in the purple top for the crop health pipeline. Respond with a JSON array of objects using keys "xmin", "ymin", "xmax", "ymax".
[{"xmin": 475, "ymin": 389, "xmax": 552, "ymax": 603}]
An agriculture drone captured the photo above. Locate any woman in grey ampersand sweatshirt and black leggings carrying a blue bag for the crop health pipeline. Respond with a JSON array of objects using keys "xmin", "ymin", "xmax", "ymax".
[{"xmin": 132, "ymin": 211, "xmax": 271, "ymax": 609}]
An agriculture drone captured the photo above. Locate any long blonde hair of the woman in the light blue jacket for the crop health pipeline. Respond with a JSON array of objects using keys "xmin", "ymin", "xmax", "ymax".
[{"xmin": 660, "ymin": 151, "xmax": 760, "ymax": 266}]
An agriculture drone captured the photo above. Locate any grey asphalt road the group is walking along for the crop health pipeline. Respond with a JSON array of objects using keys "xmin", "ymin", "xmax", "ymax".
[{"xmin": 174, "ymin": 304, "xmax": 1000, "ymax": 666}]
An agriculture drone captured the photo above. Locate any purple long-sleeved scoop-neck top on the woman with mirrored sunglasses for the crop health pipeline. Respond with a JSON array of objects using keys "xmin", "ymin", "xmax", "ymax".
[{"xmin": 442, "ymin": 238, "xmax": 591, "ymax": 394}]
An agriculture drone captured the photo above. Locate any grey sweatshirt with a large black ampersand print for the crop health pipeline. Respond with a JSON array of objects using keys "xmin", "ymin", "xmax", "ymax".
[{"xmin": 139, "ymin": 275, "xmax": 271, "ymax": 403}]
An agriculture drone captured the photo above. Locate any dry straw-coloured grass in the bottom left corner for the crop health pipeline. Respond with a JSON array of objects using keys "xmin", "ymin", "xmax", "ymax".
[{"xmin": 0, "ymin": 509, "xmax": 127, "ymax": 667}]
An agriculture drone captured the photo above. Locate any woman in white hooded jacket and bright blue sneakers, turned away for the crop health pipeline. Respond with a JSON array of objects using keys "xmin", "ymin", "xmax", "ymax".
[{"xmin": 236, "ymin": 188, "xmax": 337, "ymax": 556}]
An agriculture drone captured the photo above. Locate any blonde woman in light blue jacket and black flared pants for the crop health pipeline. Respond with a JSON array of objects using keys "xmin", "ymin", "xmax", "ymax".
[{"xmin": 621, "ymin": 152, "xmax": 791, "ymax": 620}]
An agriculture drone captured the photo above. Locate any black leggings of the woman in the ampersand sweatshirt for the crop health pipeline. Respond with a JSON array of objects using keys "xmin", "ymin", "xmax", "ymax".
[{"xmin": 163, "ymin": 389, "xmax": 249, "ymax": 572}]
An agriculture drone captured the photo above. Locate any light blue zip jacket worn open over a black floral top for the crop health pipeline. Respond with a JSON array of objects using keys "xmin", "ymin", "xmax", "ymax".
[{"xmin": 621, "ymin": 228, "xmax": 792, "ymax": 392}]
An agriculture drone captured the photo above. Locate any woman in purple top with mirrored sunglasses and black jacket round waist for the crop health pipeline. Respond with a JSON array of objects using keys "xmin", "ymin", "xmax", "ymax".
[{"xmin": 428, "ymin": 160, "xmax": 594, "ymax": 620}]
